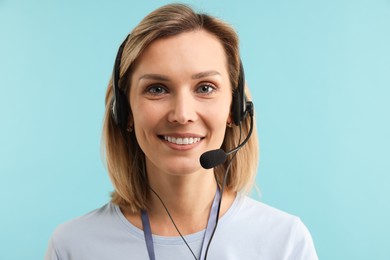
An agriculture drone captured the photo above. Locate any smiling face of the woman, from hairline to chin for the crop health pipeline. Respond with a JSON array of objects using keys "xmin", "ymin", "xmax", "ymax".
[{"xmin": 130, "ymin": 30, "xmax": 232, "ymax": 175}]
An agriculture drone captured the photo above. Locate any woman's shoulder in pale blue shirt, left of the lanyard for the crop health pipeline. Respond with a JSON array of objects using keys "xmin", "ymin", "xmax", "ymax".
[{"xmin": 45, "ymin": 203, "xmax": 149, "ymax": 260}]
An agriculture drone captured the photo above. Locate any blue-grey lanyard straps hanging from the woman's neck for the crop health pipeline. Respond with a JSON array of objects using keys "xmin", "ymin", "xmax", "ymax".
[{"xmin": 141, "ymin": 188, "xmax": 221, "ymax": 260}]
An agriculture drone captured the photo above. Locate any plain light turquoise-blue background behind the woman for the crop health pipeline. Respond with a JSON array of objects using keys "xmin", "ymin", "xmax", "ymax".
[{"xmin": 0, "ymin": 0, "xmax": 390, "ymax": 260}]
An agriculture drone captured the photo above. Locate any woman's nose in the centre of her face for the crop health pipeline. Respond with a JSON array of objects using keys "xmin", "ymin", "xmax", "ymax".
[{"xmin": 168, "ymin": 93, "xmax": 198, "ymax": 124}]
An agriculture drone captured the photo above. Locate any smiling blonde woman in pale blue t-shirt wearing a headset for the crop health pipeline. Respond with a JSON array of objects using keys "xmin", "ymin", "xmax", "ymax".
[{"xmin": 46, "ymin": 4, "xmax": 317, "ymax": 260}]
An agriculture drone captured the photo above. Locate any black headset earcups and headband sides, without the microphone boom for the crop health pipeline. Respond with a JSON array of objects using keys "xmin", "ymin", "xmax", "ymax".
[{"xmin": 111, "ymin": 35, "xmax": 253, "ymax": 131}]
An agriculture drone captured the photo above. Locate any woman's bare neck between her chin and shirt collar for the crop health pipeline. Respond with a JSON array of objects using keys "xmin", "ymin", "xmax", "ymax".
[{"xmin": 125, "ymin": 167, "xmax": 235, "ymax": 236}]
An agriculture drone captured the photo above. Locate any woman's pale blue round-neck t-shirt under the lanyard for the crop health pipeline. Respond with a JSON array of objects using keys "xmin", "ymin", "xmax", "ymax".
[{"xmin": 45, "ymin": 194, "xmax": 318, "ymax": 260}]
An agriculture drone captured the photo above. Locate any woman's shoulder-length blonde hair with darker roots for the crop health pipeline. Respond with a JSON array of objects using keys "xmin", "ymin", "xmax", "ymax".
[{"xmin": 103, "ymin": 4, "xmax": 259, "ymax": 212}]
